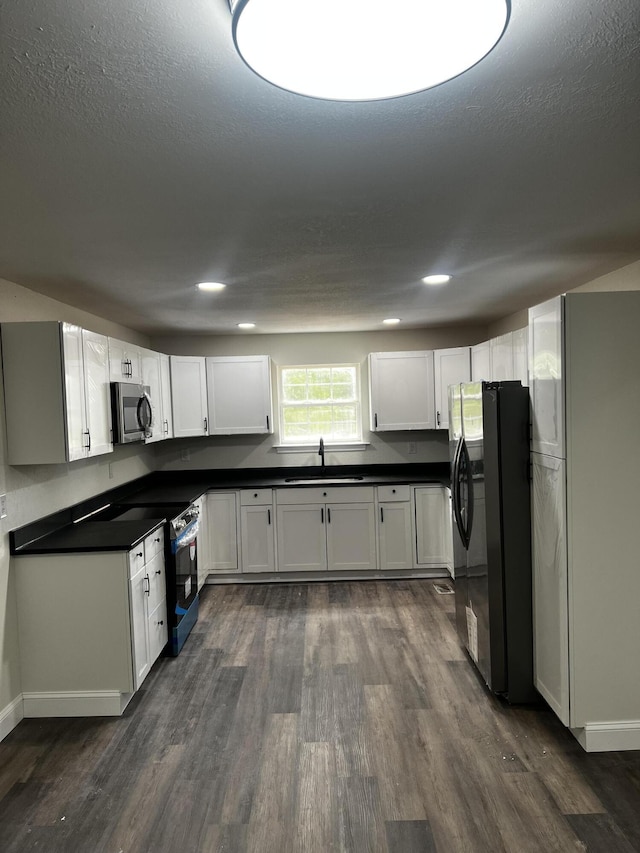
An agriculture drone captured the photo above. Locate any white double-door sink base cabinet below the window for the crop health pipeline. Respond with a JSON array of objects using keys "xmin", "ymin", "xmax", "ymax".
[{"xmin": 276, "ymin": 486, "xmax": 377, "ymax": 572}]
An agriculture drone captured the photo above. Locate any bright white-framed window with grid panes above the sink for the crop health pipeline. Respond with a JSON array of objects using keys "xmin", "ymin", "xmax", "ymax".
[{"xmin": 278, "ymin": 364, "xmax": 362, "ymax": 444}]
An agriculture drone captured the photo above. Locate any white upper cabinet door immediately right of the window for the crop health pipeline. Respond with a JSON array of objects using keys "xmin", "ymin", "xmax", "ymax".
[{"xmin": 369, "ymin": 352, "xmax": 435, "ymax": 432}]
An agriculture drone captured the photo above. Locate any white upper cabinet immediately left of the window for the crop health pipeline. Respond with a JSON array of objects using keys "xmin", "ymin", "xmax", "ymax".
[{"xmin": 206, "ymin": 355, "xmax": 273, "ymax": 435}]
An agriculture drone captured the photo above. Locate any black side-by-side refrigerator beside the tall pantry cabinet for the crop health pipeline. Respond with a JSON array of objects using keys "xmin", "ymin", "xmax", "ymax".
[{"xmin": 449, "ymin": 382, "xmax": 537, "ymax": 703}]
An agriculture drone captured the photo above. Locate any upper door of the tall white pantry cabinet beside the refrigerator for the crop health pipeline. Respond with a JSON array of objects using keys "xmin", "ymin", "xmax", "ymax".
[{"xmin": 529, "ymin": 296, "xmax": 564, "ymax": 457}]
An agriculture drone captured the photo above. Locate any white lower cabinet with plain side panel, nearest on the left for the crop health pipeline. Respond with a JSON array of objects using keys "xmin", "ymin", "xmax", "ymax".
[{"xmin": 15, "ymin": 528, "xmax": 168, "ymax": 717}]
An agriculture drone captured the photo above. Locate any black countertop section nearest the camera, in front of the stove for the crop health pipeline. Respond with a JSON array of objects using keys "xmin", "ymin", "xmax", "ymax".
[{"xmin": 15, "ymin": 513, "xmax": 164, "ymax": 555}]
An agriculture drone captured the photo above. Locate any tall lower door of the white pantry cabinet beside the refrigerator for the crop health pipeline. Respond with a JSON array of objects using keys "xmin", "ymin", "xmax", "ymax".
[{"xmin": 531, "ymin": 453, "xmax": 570, "ymax": 726}]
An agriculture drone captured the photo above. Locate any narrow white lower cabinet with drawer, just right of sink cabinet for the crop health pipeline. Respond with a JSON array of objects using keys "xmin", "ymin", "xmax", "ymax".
[{"xmin": 377, "ymin": 486, "xmax": 413, "ymax": 569}]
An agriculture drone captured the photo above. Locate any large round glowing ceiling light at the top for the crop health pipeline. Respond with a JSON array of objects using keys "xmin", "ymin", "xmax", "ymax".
[{"xmin": 229, "ymin": 0, "xmax": 510, "ymax": 101}]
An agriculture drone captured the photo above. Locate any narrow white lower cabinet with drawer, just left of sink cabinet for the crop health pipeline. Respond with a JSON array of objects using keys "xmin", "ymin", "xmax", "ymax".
[{"xmin": 240, "ymin": 489, "xmax": 276, "ymax": 574}]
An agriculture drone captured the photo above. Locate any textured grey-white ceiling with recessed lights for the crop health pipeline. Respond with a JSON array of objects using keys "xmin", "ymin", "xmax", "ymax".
[{"xmin": 0, "ymin": 0, "xmax": 640, "ymax": 334}]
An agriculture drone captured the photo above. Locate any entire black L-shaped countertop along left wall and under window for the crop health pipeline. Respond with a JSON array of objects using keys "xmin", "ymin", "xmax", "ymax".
[{"xmin": 9, "ymin": 463, "xmax": 449, "ymax": 555}]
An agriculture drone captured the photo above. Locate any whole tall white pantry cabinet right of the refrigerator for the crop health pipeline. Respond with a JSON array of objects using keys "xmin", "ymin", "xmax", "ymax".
[{"xmin": 529, "ymin": 291, "xmax": 640, "ymax": 751}]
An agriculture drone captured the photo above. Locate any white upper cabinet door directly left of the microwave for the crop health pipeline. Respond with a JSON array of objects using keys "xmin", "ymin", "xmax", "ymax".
[{"xmin": 82, "ymin": 329, "xmax": 113, "ymax": 456}]
